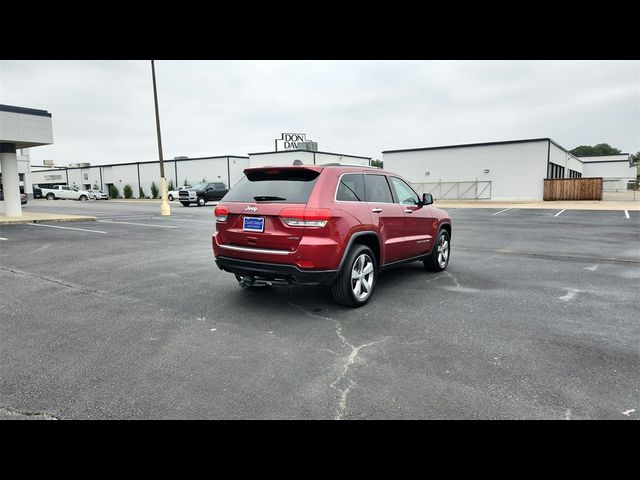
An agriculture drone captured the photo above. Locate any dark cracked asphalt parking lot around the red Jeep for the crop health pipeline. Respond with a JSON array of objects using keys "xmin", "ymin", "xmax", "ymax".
[{"xmin": 0, "ymin": 200, "xmax": 640, "ymax": 420}]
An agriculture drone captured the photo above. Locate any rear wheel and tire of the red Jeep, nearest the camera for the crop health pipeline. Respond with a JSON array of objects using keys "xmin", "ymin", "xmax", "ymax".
[{"xmin": 331, "ymin": 245, "xmax": 378, "ymax": 308}]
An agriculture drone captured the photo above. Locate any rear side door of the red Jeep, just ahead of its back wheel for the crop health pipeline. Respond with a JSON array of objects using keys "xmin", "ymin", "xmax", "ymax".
[{"xmin": 364, "ymin": 173, "xmax": 404, "ymax": 264}]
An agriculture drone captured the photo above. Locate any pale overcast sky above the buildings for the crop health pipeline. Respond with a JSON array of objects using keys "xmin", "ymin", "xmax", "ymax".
[{"xmin": 0, "ymin": 60, "xmax": 640, "ymax": 165}]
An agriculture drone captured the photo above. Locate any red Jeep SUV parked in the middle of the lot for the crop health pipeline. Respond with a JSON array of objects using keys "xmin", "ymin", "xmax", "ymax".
[{"xmin": 211, "ymin": 164, "xmax": 451, "ymax": 307}]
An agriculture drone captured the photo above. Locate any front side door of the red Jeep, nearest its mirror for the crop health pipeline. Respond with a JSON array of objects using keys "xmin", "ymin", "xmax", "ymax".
[{"xmin": 389, "ymin": 177, "xmax": 434, "ymax": 258}]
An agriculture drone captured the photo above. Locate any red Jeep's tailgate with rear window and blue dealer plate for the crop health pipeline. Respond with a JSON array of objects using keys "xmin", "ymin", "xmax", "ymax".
[{"xmin": 216, "ymin": 167, "xmax": 320, "ymax": 251}]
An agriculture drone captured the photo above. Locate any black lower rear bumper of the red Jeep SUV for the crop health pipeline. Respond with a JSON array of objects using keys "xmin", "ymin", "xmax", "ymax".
[{"xmin": 216, "ymin": 256, "xmax": 338, "ymax": 285}]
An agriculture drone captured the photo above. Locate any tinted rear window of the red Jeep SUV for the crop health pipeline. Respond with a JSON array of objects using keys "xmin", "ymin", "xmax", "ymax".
[{"xmin": 222, "ymin": 169, "xmax": 320, "ymax": 203}]
